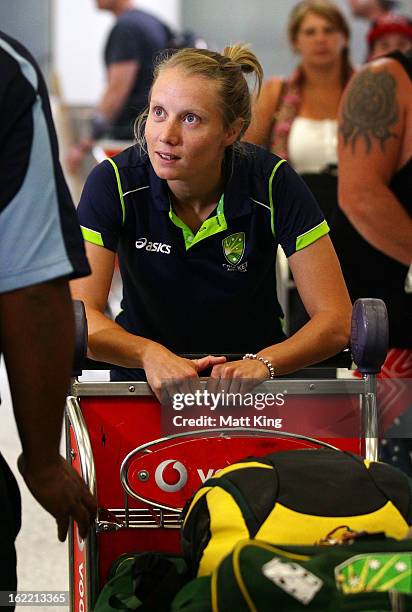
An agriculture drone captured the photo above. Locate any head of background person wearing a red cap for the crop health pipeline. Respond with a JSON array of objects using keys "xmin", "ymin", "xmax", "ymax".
[{"xmin": 368, "ymin": 13, "xmax": 412, "ymax": 60}]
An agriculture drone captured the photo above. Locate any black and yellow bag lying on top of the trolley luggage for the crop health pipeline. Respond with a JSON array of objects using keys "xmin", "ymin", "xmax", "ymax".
[{"xmin": 182, "ymin": 449, "xmax": 412, "ymax": 576}]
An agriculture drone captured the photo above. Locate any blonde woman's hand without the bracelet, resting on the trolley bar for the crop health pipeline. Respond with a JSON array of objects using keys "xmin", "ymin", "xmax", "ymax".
[{"xmin": 142, "ymin": 342, "xmax": 226, "ymax": 401}]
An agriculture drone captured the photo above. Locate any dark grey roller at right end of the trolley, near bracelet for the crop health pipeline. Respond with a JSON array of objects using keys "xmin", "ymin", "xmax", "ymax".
[{"xmin": 351, "ymin": 298, "xmax": 389, "ymax": 374}]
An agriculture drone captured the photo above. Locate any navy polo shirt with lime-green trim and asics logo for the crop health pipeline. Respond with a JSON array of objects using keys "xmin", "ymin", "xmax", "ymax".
[{"xmin": 78, "ymin": 143, "xmax": 328, "ymax": 354}]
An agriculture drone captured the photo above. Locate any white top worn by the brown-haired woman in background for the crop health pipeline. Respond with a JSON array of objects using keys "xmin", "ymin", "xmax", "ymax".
[{"xmin": 288, "ymin": 117, "xmax": 338, "ymax": 174}]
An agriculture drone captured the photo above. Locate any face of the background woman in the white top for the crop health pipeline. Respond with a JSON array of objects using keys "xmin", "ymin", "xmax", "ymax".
[{"xmin": 294, "ymin": 13, "xmax": 347, "ymax": 66}]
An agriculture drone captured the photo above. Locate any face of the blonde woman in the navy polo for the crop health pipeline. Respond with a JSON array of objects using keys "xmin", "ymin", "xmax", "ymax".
[{"xmin": 145, "ymin": 68, "xmax": 237, "ymax": 184}]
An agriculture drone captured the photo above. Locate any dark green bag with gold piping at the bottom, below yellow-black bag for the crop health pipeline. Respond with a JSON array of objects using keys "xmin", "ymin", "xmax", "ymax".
[{"xmin": 171, "ymin": 534, "xmax": 412, "ymax": 612}]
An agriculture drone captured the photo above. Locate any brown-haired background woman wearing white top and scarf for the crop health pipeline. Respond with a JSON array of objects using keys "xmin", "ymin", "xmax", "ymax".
[{"xmin": 244, "ymin": 0, "xmax": 353, "ymax": 332}]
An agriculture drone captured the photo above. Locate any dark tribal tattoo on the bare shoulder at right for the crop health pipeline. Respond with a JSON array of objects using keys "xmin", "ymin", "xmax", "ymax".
[{"xmin": 340, "ymin": 70, "xmax": 399, "ymax": 153}]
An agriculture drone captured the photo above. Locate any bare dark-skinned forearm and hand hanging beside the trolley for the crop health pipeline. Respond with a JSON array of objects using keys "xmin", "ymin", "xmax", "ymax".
[{"xmin": 0, "ymin": 279, "xmax": 96, "ymax": 541}]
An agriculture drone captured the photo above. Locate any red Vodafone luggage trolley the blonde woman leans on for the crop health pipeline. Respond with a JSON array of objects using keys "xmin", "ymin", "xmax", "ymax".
[{"xmin": 66, "ymin": 299, "xmax": 388, "ymax": 611}]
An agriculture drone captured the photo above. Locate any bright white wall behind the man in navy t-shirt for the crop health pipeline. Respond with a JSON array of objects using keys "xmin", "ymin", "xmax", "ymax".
[{"xmin": 52, "ymin": 0, "xmax": 180, "ymax": 106}]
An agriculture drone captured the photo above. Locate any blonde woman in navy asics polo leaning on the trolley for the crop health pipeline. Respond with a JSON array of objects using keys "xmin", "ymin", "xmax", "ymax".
[{"xmin": 72, "ymin": 44, "xmax": 351, "ymax": 397}]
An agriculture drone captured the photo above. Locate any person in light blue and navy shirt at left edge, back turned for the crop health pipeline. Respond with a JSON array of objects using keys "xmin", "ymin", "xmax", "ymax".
[{"xmin": 0, "ymin": 32, "xmax": 96, "ymax": 591}]
